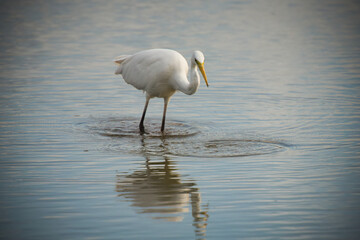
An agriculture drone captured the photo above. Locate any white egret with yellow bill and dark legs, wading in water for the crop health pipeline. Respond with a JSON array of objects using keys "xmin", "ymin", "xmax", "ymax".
[{"xmin": 114, "ymin": 49, "xmax": 209, "ymax": 133}]
